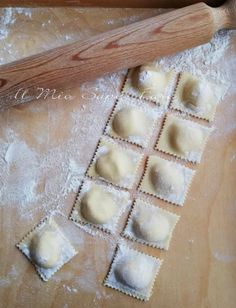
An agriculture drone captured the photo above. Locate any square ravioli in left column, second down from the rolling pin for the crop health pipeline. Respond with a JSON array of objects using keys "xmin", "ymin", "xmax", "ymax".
[{"xmin": 105, "ymin": 96, "xmax": 163, "ymax": 147}]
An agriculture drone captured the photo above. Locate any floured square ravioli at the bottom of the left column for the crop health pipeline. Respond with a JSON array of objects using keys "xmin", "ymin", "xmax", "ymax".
[{"xmin": 70, "ymin": 180, "xmax": 131, "ymax": 233}]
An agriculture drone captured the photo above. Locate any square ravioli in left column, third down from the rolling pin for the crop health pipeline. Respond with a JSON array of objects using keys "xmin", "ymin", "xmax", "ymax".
[{"xmin": 87, "ymin": 138, "xmax": 143, "ymax": 188}]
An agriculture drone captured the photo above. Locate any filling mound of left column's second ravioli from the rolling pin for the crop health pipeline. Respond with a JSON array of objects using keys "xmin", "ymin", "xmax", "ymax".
[{"xmin": 112, "ymin": 107, "xmax": 149, "ymax": 138}]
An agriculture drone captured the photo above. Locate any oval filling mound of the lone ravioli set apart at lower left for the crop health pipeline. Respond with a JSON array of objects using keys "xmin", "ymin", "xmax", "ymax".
[{"xmin": 30, "ymin": 231, "xmax": 60, "ymax": 269}]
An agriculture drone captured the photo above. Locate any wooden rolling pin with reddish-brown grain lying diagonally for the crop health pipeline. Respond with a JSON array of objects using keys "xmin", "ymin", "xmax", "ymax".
[{"xmin": 0, "ymin": 0, "xmax": 236, "ymax": 110}]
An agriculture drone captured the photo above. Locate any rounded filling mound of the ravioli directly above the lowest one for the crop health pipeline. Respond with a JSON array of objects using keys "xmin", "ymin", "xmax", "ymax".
[{"xmin": 133, "ymin": 211, "xmax": 170, "ymax": 242}]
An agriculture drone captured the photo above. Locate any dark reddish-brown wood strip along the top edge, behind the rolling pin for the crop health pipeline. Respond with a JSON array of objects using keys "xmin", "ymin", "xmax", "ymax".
[{"xmin": 0, "ymin": 0, "xmax": 223, "ymax": 8}]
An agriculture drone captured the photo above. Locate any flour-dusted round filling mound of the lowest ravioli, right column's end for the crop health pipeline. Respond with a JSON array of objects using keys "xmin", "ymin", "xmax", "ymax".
[{"xmin": 115, "ymin": 254, "xmax": 153, "ymax": 290}]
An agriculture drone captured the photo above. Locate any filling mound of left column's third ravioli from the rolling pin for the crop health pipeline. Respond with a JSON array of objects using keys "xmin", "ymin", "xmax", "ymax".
[{"xmin": 95, "ymin": 149, "xmax": 133, "ymax": 183}]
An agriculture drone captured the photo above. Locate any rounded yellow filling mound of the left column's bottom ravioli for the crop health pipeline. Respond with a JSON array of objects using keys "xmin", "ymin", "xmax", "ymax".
[{"xmin": 81, "ymin": 186, "xmax": 118, "ymax": 224}]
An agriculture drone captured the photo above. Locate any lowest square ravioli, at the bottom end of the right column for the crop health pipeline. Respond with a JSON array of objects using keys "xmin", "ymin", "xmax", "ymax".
[{"xmin": 104, "ymin": 244, "xmax": 162, "ymax": 301}]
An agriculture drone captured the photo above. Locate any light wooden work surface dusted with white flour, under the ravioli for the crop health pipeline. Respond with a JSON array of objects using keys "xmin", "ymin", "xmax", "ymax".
[{"xmin": 0, "ymin": 9, "xmax": 236, "ymax": 308}]
